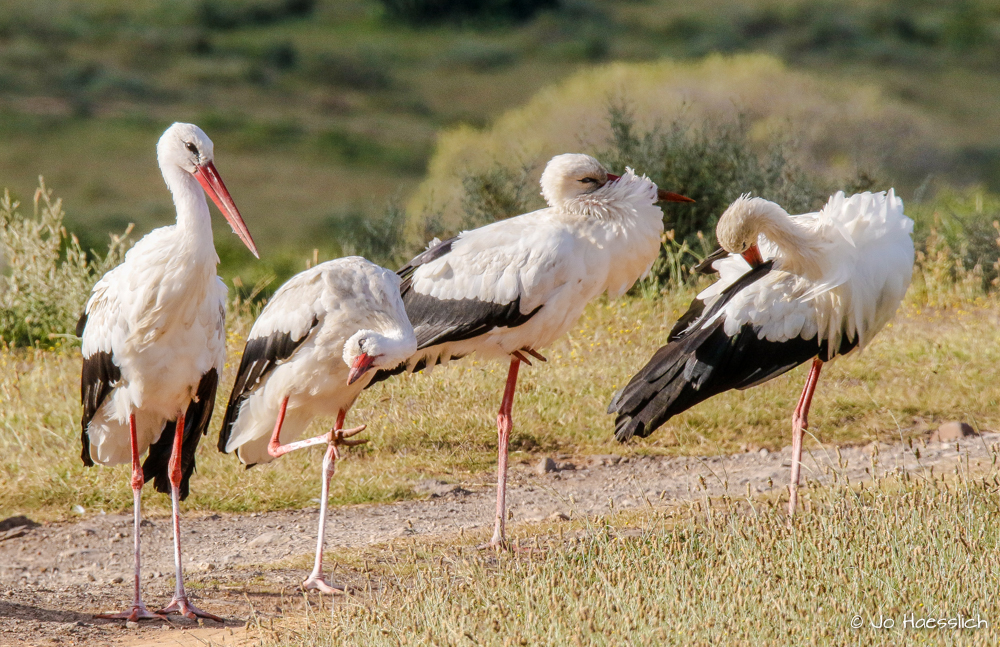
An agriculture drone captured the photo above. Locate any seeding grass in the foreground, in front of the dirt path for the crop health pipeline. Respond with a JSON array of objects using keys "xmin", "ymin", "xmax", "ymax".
[{"xmin": 252, "ymin": 468, "xmax": 1000, "ymax": 647}]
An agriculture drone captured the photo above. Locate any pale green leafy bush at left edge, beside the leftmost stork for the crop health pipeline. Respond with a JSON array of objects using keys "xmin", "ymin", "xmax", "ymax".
[{"xmin": 0, "ymin": 178, "xmax": 131, "ymax": 346}]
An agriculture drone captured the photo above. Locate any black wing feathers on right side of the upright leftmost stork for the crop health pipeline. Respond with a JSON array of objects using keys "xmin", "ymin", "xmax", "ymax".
[{"xmin": 142, "ymin": 368, "xmax": 219, "ymax": 501}]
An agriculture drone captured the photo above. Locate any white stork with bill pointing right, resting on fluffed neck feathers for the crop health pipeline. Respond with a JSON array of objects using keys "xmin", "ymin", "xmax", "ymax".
[{"xmin": 376, "ymin": 154, "xmax": 693, "ymax": 547}]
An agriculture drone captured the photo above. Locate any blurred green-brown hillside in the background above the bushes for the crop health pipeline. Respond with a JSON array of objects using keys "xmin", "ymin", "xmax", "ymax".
[{"xmin": 0, "ymin": 0, "xmax": 1000, "ymax": 274}]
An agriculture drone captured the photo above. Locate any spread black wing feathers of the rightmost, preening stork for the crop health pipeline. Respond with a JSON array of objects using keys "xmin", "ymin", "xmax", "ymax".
[{"xmin": 608, "ymin": 262, "xmax": 857, "ymax": 442}]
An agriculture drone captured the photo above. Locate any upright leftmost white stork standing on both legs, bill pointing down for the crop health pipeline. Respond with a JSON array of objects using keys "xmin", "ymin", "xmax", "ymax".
[{"xmin": 76, "ymin": 123, "xmax": 257, "ymax": 621}]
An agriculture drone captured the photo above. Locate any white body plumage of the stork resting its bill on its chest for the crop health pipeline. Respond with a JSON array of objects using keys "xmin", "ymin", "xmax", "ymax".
[{"xmin": 398, "ymin": 162, "xmax": 663, "ymax": 370}]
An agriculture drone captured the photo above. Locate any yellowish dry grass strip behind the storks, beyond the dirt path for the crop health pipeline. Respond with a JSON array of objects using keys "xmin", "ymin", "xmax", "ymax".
[{"xmin": 0, "ymin": 284, "xmax": 1000, "ymax": 518}]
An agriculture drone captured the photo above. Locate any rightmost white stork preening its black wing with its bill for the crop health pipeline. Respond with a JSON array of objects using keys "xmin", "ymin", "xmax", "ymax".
[{"xmin": 608, "ymin": 189, "xmax": 913, "ymax": 515}]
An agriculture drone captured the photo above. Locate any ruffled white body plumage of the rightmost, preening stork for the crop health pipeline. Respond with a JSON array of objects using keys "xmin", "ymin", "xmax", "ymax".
[{"xmin": 698, "ymin": 189, "xmax": 914, "ymax": 356}]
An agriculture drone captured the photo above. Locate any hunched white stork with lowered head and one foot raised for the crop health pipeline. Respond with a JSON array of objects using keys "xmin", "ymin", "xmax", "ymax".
[{"xmin": 219, "ymin": 256, "xmax": 417, "ymax": 593}]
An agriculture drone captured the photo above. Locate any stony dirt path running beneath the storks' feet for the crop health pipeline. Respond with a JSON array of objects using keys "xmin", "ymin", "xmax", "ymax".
[{"xmin": 0, "ymin": 433, "xmax": 1000, "ymax": 647}]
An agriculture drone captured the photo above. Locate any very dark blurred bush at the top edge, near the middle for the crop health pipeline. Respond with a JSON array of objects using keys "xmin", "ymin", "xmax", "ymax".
[{"xmin": 382, "ymin": 0, "xmax": 559, "ymax": 25}]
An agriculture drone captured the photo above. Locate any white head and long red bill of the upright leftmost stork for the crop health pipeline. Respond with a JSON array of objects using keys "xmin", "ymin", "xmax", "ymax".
[{"xmin": 156, "ymin": 122, "xmax": 260, "ymax": 258}]
